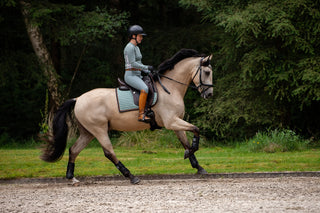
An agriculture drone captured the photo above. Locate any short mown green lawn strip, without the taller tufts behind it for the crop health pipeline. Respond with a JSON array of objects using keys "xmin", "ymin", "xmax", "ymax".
[{"xmin": 0, "ymin": 146, "xmax": 320, "ymax": 179}]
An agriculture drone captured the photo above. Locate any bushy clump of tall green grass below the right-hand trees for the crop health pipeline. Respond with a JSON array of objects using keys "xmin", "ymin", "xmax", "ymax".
[{"xmin": 245, "ymin": 129, "xmax": 309, "ymax": 153}]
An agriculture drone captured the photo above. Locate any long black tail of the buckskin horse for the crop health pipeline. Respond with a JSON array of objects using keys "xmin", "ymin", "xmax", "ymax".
[{"xmin": 40, "ymin": 99, "xmax": 76, "ymax": 162}]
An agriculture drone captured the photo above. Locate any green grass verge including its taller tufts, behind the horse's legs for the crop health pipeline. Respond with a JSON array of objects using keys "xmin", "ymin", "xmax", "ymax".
[{"xmin": 0, "ymin": 130, "xmax": 320, "ymax": 179}]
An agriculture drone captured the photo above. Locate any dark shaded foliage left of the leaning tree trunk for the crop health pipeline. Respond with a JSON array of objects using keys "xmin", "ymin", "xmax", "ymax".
[{"xmin": 0, "ymin": 4, "xmax": 46, "ymax": 139}]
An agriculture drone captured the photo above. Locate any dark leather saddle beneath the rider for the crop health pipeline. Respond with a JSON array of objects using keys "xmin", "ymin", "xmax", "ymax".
[{"xmin": 118, "ymin": 76, "xmax": 158, "ymax": 109}]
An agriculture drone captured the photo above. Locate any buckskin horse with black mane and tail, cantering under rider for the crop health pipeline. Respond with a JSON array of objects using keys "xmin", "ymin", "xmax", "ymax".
[{"xmin": 40, "ymin": 49, "xmax": 213, "ymax": 184}]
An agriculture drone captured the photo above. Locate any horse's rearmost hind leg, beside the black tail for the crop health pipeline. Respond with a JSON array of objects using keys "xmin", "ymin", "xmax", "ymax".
[{"xmin": 66, "ymin": 123, "xmax": 93, "ymax": 179}]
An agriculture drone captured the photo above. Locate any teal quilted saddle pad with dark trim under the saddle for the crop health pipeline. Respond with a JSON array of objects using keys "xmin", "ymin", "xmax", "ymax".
[{"xmin": 116, "ymin": 88, "xmax": 158, "ymax": 112}]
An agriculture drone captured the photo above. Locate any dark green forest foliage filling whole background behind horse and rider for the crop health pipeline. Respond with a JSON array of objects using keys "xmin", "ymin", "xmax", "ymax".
[{"xmin": 0, "ymin": 0, "xmax": 320, "ymax": 144}]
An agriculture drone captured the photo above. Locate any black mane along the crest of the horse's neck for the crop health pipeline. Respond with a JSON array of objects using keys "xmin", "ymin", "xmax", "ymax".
[{"xmin": 158, "ymin": 49, "xmax": 203, "ymax": 73}]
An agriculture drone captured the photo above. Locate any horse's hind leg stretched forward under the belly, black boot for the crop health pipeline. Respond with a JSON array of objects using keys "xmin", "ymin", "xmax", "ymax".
[{"xmin": 96, "ymin": 129, "xmax": 140, "ymax": 184}]
